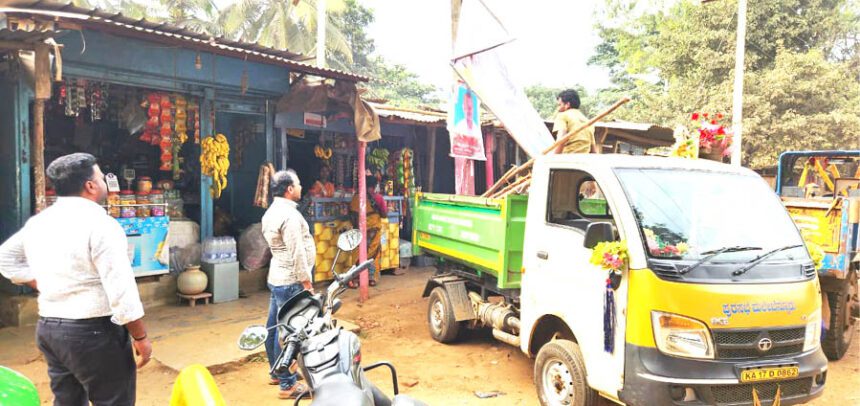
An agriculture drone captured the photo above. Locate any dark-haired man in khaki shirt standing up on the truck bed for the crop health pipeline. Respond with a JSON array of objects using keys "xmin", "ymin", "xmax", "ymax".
[{"xmin": 552, "ymin": 89, "xmax": 595, "ymax": 154}]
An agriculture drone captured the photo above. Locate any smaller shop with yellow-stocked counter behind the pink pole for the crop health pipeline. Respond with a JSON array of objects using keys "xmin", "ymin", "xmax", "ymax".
[{"xmin": 277, "ymin": 111, "xmax": 425, "ymax": 281}]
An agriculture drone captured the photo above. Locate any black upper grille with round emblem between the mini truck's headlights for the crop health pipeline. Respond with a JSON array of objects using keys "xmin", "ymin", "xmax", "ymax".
[{"xmin": 713, "ymin": 327, "xmax": 806, "ymax": 359}]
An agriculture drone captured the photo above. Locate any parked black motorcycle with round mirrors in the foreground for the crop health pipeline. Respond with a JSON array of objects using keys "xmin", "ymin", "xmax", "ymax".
[{"xmin": 238, "ymin": 229, "xmax": 426, "ymax": 406}]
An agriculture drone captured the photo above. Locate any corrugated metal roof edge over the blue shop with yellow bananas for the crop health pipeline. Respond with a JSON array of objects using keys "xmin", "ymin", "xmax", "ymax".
[{"xmin": 0, "ymin": 0, "xmax": 368, "ymax": 82}]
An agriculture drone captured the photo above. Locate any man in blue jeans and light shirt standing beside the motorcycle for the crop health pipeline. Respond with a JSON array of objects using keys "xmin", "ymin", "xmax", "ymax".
[{"xmin": 263, "ymin": 169, "xmax": 316, "ymax": 399}]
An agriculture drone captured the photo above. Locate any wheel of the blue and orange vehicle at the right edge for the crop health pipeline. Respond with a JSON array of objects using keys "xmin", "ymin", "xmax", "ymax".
[{"xmin": 821, "ymin": 273, "xmax": 857, "ymax": 361}]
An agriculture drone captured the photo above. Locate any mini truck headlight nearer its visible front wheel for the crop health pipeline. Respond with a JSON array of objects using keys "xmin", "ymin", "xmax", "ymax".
[{"xmin": 651, "ymin": 311, "xmax": 714, "ymax": 359}]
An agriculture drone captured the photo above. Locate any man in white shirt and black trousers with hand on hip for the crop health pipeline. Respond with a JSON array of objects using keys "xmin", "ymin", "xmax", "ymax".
[{"xmin": 0, "ymin": 153, "xmax": 152, "ymax": 406}]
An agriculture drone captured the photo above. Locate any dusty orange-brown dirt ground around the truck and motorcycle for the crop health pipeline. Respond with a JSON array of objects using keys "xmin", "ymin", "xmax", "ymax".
[{"xmin": 0, "ymin": 268, "xmax": 860, "ymax": 406}]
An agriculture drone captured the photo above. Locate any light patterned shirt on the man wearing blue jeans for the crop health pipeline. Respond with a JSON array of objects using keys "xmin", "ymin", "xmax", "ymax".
[{"xmin": 263, "ymin": 197, "xmax": 317, "ymax": 286}]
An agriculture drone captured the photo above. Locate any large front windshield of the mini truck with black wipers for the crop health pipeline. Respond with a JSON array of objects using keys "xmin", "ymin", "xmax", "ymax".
[{"xmin": 616, "ymin": 169, "xmax": 809, "ymax": 268}]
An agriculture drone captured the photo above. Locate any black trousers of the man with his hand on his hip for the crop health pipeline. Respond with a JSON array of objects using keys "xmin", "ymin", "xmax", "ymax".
[{"xmin": 36, "ymin": 317, "xmax": 137, "ymax": 406}]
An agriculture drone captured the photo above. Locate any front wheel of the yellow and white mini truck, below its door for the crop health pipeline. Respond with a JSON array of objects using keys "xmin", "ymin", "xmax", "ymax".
[{"xmin": 534, "ymin": 340, "xmax": 598, "ymax": 406}]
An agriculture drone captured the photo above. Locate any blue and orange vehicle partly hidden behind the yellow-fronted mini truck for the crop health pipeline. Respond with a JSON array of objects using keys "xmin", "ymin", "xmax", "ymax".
[{"xmin": 776, "ymin": 150, "xmax": 860, "ymax": 360}]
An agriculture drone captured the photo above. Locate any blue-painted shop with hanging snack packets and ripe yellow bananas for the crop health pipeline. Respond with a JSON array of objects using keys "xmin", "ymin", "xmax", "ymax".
[{"xmin": 0, "ymin": 3, "xmax": 361, "ymax": 320}]
